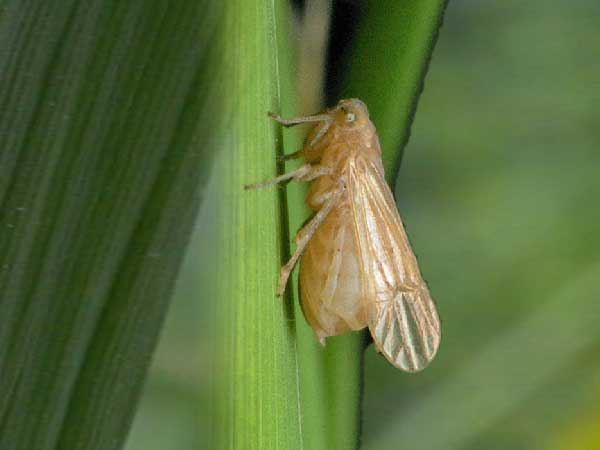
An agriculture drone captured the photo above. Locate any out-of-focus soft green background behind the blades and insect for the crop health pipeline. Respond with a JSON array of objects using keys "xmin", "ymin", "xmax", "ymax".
[{"xmin": 126, "ymin": 0, "xmax": 600, "ymax": 450}]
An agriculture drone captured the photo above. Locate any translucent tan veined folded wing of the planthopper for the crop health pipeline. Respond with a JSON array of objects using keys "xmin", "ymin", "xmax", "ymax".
[{"xmin": 348, "ymin": 157, "xmax": 441, "ymax": 372}]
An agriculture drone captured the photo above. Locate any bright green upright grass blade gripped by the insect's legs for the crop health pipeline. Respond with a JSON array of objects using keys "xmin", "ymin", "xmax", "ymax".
[{"xmin": 211, "ymin": 0, "xmax": 303, "ymax": 450}]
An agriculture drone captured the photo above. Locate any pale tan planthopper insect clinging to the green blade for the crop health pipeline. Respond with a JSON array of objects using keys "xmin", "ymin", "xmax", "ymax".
[{"xmin": 245, "ymin": 99, "xmax": 441, "ymax": 372}]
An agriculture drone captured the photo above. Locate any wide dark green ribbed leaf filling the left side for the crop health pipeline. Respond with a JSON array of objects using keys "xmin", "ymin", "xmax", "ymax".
[{"xmin": 0, "ymin": 0, "xmax": 225, "ymax": 450}]
